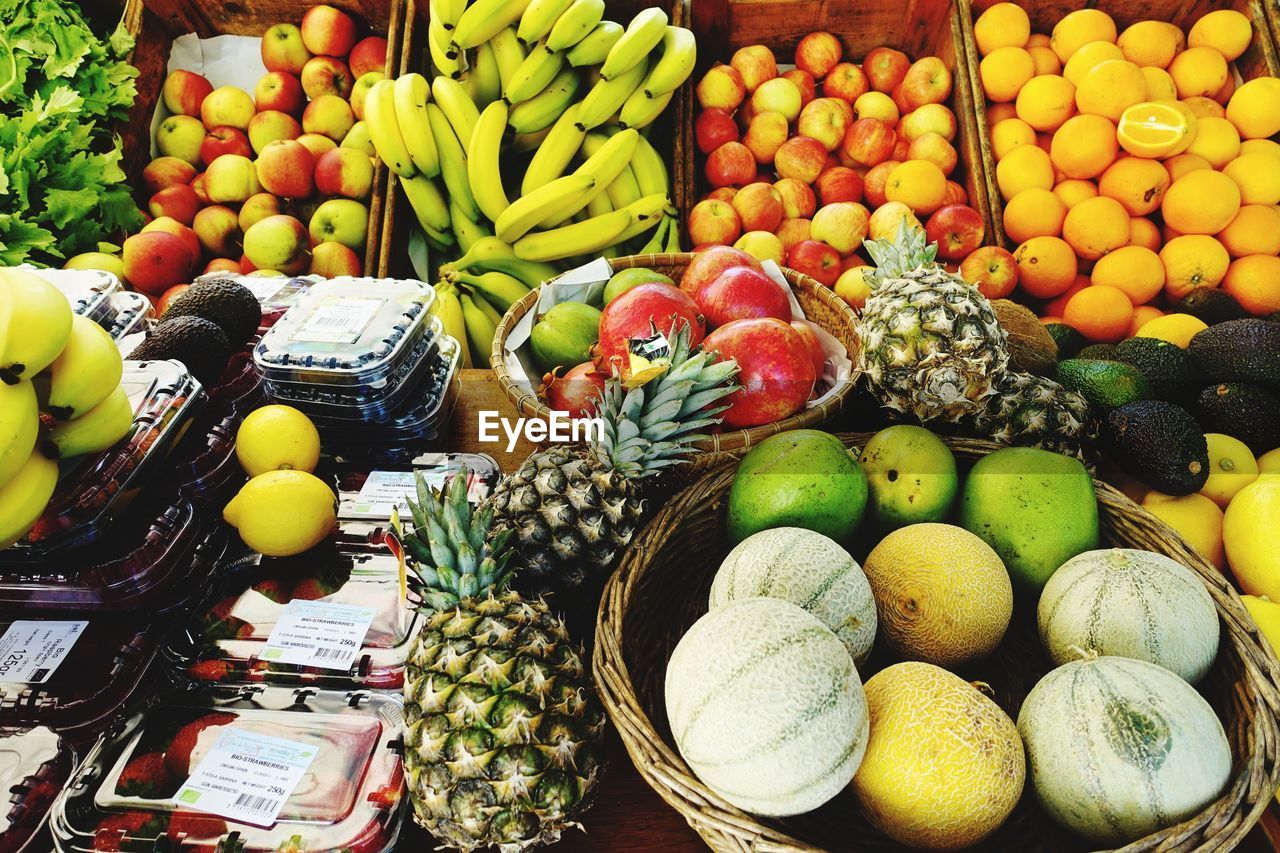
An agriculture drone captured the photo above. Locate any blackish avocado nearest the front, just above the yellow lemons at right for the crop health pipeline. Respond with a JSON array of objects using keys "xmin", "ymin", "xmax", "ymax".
[{"xmin": 1102, "ymin": 400, "xmax": 1208, "ymax": 496}]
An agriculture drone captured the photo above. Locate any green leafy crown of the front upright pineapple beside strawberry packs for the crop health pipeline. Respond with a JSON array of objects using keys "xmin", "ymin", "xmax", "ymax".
[{"xmin": 403, "ymin": 465, "xmax": 515, "ymax": 611}]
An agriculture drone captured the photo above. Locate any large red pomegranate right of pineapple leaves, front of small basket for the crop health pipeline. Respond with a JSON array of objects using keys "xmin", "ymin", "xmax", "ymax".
[{"xmin": 703, "ymin": 316, "xmax": 817, "ymax": 429}]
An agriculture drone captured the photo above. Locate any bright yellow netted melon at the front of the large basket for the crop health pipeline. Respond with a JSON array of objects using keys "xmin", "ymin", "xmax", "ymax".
[{"xmin": 854, "ymin": 662, "xmax": 1027, "ymax": 850}]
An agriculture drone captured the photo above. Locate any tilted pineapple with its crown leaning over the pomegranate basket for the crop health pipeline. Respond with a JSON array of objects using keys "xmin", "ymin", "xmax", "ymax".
[{"xmin": 492, "ymin": 321, "xmax": 737, "ymax": 592}]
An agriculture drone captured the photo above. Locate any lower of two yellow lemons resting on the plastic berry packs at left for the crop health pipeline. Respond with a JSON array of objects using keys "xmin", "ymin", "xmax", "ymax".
[{"xmin": 223, "ymin": 471, "xmax": 337, "ymax": 557}]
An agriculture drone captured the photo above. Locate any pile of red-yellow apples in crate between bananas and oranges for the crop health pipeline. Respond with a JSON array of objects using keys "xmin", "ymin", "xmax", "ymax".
[{"xmin": 687, "ymin": 32, "xmax": 984, "ymax": 307}]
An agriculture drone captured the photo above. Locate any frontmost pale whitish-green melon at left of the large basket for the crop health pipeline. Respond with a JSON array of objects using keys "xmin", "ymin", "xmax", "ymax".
[{"xmin": 666, "ymin": 598, "xmax": 868, "ymax": 817}]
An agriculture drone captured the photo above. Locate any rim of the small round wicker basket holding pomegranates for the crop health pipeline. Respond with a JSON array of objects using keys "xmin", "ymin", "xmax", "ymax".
[{"xmin": 489, "ymin": 252, "xmax": 858, "ymax": 453}]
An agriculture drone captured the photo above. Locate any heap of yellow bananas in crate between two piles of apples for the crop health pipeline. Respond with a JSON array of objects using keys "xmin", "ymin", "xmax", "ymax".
[{"xmin": 365, "ymin": 0, "xmax": 696, "ymax": 281}]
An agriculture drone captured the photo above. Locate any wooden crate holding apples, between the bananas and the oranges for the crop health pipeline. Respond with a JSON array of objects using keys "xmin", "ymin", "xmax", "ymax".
[{"xmin": 681, "ymin": 0, "xmax": 992, "ymax": 242}]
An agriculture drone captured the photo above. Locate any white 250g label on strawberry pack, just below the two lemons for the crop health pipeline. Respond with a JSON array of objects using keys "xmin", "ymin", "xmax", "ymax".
[{"xmin": 259, "ymin": 598, "xmax": 378, "ymax": 670}]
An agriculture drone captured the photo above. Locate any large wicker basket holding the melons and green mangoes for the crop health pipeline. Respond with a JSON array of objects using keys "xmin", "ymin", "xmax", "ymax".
[{"xmin": 593, "ymin": 434, "xmax": 1280, "ymax": 853}]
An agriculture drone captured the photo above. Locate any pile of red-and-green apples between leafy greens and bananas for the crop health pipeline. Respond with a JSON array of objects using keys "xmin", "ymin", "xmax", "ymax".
[{"xmin": 123, "ymin": 5, "xmax": 387, "ymax": 306}]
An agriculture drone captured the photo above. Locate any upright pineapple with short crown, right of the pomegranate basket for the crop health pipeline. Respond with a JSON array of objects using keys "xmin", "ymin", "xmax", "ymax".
[{"xmin": 858, "ymin": 220, "xmax": 1009, "ymax": 423}]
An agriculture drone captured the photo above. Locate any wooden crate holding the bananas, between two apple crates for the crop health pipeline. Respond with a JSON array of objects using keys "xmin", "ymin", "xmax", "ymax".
[{"xmin": 375, "ymin": 0, "xmax": 692, "ymax": 277}]
